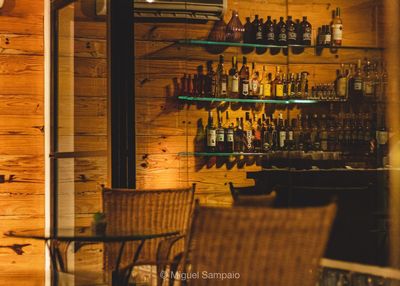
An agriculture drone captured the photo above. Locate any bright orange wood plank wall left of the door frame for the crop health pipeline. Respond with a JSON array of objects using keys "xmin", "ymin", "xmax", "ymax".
[{"xmin": 0, "ymin": 0, "xmax": 44, "ymax": 285}]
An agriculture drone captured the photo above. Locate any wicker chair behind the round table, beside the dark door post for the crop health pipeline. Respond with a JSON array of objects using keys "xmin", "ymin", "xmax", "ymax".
[{"xmin": 103, "ymin": 184, "xmax": 195, "ymax": 285}]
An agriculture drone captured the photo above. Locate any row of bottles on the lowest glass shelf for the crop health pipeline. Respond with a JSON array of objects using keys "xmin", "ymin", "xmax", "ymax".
[{"xmin": 205, "ymin": 111, "xmax": 388, "ymax": 159}]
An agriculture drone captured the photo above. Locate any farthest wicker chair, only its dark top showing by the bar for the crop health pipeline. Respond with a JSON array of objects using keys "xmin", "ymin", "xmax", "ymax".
[{"xmin": 229, "ymin": 182, "xmax": 276, "ymax": 207}]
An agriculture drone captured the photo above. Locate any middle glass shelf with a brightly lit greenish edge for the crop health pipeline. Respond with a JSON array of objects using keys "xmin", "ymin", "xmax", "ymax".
[{"xmin": 178, "ymin": 96, "xmax": 318, "ymax": 104}]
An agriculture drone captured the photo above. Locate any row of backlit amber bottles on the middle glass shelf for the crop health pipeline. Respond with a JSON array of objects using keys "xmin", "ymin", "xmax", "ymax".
[{"xmin": 179, "ymin": 55, "xmax": 387, "ymax": 101}]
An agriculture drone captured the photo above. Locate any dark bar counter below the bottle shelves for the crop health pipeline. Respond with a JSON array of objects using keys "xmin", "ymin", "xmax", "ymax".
[{"xmin": 247, "ymin": 168, "xmax": 390, "ymax": 266}]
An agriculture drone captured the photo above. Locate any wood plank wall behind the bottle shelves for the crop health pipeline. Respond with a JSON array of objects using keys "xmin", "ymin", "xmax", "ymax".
[{"xmin": 135, "ymin": 0, "xmax": 382, "ymax": 205}]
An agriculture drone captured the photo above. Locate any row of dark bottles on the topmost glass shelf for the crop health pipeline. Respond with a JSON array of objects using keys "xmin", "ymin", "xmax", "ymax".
[{"xmin": 223, "ymin": 8, "xmax": 343, "ymax": 48}]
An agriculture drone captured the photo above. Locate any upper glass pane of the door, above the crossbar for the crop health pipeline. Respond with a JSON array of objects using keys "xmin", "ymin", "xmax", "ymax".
[{"xmin": 55, "ymin": 1, "xmax": 107, "ymax": 152}]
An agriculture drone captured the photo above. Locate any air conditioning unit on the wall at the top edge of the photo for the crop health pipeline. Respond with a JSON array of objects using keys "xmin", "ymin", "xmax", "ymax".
[{"xmin": 96, "ymin": 0, "xmax": 227, "ymax": 20}]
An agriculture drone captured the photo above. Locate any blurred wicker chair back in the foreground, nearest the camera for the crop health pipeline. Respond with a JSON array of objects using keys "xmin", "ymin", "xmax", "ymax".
[{"xmin": 185, "ymin": 204, "xmax": 336, "ymax": 286}]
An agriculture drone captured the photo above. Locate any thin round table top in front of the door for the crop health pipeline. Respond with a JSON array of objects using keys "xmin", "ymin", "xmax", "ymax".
[{"xmin": 4, "ymin": 227, "xmax": 180, "ymax": 242}]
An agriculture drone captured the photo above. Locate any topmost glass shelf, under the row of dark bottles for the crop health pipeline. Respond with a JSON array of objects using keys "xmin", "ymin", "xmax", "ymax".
[{"xmin": 177, "ymin": 39, "xmax": 384, "ymax": 51}]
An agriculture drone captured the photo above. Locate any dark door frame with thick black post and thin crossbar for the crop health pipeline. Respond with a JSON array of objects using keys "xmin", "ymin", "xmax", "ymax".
[{"xmin": 49, "ymin": 0, "xmax": 136, "ymax": 234}]
